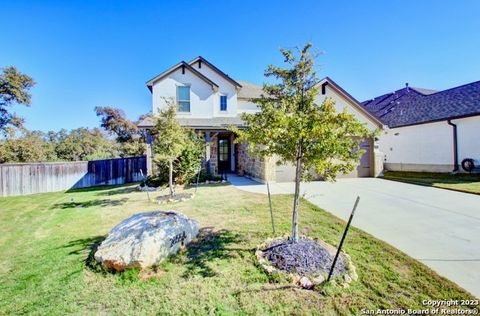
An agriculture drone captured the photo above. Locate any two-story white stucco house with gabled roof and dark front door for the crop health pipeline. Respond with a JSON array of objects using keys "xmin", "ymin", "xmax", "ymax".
[{"xmin": 139, "ymin": 57, "xmax": 382, "ymax": 182}]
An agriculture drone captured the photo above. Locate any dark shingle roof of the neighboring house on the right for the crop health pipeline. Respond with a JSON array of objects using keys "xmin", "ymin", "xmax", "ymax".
[{"xmin": 362, "ymin": 81, "xmax": 480, "ymax": 127}]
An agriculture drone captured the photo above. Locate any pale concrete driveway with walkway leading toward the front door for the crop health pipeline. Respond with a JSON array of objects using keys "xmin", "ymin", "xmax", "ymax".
[{"xmin": 229, "ymin": 177, "xmax": 480, "ymax": 297}]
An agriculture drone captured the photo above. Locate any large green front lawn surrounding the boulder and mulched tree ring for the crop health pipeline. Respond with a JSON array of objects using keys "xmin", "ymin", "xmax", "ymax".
[{"xmin": 0, "ymin": 185, "xmax": 473, "ymax": 315}]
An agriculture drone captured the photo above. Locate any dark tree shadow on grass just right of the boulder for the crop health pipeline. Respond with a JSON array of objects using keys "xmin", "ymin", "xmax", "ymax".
[{"xmin": 178, "ymin": 227, "xmax": 255, "ymax": 278}]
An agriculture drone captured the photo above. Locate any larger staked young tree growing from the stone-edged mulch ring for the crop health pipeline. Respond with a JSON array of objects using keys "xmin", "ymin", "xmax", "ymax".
[{"xmin": 236, "ymin": 44, "xmax": 371, "ymax": 242}]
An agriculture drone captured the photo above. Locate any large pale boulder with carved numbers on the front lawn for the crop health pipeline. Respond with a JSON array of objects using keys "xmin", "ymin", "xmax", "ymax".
[{"xmin": 95, "ymin": 211, "xmax": 198, "ymax": 271}]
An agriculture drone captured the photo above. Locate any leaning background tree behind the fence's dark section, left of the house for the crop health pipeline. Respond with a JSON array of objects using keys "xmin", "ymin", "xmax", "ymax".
[{"xmin": 95, "ymin": 106, "xmax": 145, "ymax": 156}]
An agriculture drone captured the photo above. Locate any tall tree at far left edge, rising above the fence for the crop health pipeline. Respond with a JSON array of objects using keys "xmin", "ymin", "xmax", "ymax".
[{"xmin": 0, "ymin": 67, "xmax": 35, "ymax": 135}]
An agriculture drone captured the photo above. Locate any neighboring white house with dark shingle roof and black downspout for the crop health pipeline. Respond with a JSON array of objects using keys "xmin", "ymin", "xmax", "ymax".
[{"xmin": 362, "ymin": 81, "xmax": 480, "ymax": 172}]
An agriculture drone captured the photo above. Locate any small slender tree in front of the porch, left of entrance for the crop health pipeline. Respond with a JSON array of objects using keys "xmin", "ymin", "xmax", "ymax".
[{"xmin": 152, "ymin": 99, "xmax": 188, "ymax": 196}]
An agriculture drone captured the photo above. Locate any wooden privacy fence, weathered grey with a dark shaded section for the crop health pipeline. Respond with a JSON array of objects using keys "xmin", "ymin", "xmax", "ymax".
[{"xmin": 0, "ymin": 156, "xmax": 147, "ymax": 196}]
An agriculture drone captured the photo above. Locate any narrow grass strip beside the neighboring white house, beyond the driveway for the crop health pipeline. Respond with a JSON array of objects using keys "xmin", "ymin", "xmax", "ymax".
[{"xmin": 384, "ymin": 171, "xmax": 480, "ymax": 194}]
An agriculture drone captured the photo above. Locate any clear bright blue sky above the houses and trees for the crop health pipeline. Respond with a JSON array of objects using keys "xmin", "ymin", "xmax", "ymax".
[{"xmin": 0, "ymin": 0, "xmax": 480, "ymax": 130}]
